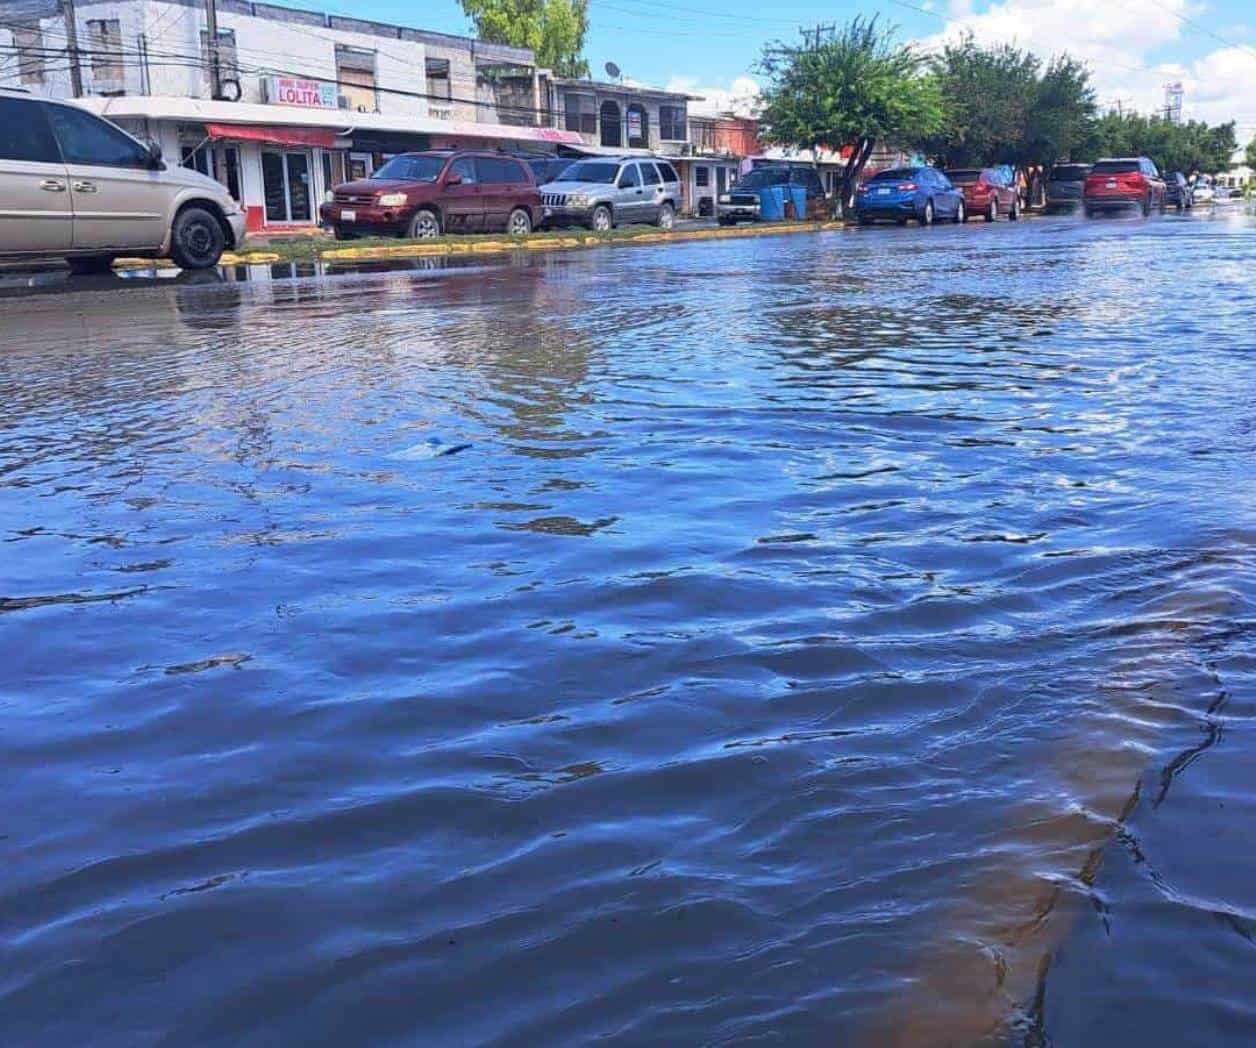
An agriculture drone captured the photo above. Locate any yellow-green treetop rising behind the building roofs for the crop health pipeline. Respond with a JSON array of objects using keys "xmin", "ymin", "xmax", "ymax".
[{"xmin": 461, "ymin": 0, "xmax": 589, "ymax": 77}]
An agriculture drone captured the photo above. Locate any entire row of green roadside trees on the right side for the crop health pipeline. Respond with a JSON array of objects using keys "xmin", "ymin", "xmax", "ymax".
[{"xmin": 759, "ymin": 18, "xmax": 1256, "ymax": 209}]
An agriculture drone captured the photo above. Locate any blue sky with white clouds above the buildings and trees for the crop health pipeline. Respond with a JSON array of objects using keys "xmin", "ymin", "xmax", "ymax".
[{"xmin": 321, "ymin": 0, "xmax": 1256, "ymax": 141}]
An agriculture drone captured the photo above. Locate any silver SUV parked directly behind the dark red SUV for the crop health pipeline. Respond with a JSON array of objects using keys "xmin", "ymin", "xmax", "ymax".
[{"xmin": 541, "ymin": 157, "xmax": 681, "ymax": 232}]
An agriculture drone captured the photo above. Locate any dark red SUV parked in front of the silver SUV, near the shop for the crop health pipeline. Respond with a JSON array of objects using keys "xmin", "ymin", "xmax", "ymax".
[{"xmin": 319, "ymin": 150, "xmax": 541, "ymax": 240}]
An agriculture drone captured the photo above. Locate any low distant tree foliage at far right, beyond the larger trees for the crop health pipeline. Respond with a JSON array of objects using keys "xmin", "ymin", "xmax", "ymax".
[{"xmin": 1083, "ymin": 113, "xmax": 1238, "ymax": 175}]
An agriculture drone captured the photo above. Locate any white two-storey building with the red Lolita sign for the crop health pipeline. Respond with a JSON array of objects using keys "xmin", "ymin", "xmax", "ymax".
[{"xmin": 0, "ymin": 0, "xmax": 582, "ymax": 231}]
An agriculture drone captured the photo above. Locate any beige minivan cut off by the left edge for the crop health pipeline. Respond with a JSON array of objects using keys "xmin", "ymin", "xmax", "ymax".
[{"xmin": 0, "ymin": 90, "xmax": 245, "ymax": 273}]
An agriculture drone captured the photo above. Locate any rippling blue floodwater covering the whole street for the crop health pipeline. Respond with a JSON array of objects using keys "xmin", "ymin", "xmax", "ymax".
[{"xmin": 0, "ymin": 215, "xmax": 1256, "ymax": 1045}]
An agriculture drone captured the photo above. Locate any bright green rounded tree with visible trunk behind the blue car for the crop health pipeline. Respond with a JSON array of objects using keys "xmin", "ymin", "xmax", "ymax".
[{"xmin": 757, "ymin": 18, "xmax": 943, "ymax": 211}]
